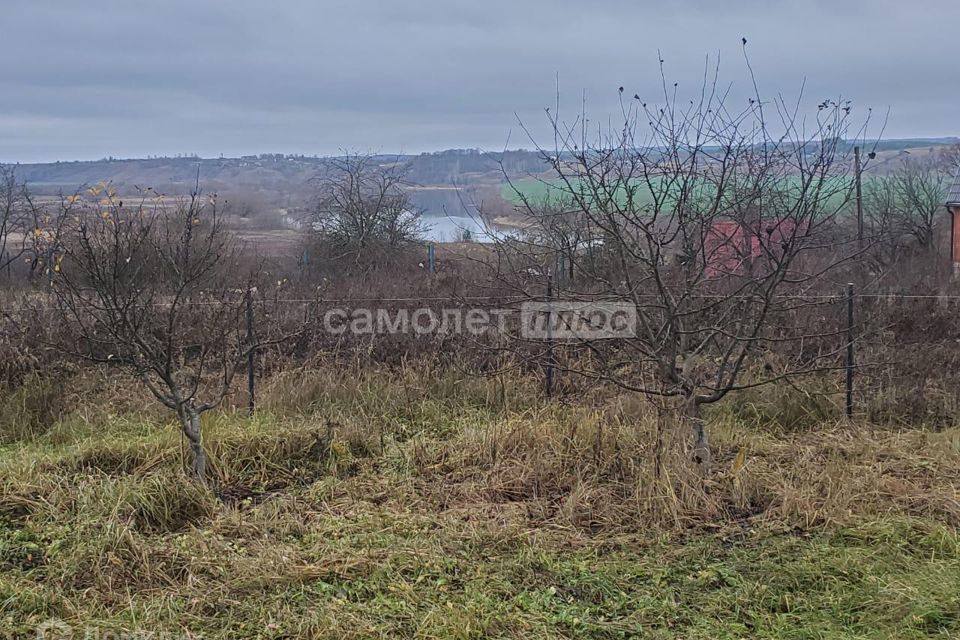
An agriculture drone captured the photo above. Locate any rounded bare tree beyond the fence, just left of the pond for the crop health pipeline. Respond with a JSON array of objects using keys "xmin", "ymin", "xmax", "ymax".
[{"xmin": 308, "ymin": 154, "xmax": 422, "ymax": 263}]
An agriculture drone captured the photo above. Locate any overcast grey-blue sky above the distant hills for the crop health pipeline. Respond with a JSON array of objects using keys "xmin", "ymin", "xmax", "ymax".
[{"xmin": 0, "ymin": 0, "xmax": 960, "ymax": 162}]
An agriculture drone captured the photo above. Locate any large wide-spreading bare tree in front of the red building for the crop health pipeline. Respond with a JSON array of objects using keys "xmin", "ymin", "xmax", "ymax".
[{"xmin": 498, "ymin": 55, "xmax": 864, "ymax": 468}]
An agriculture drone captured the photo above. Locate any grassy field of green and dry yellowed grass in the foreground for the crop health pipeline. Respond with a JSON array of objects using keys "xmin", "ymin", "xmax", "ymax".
[{"xmin": 0, "ymin": 367, "xmax": 960, "ymax": 639}]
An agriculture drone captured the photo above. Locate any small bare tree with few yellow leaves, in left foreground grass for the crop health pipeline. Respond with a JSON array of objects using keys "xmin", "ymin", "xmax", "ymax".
[{"xmin": 53, "ymin": 182, "xmax": 258, "ymax": 481}]
